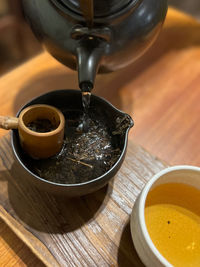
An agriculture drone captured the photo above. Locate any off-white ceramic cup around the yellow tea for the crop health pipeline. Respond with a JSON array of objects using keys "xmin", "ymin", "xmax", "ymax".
[{"xmin": 130, "ymin": 165, "xmax": 200, "ymax": 267}]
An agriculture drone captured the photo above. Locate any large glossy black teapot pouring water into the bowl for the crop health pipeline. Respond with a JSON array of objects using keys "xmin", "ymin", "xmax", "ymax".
[{"xmin": 22, "ymin": 0, "xmax": 167, "ymax": 92}]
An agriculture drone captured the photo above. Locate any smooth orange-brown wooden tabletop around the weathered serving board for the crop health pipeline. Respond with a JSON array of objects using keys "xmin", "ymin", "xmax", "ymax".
[{"xmin": 0, "ymin": 9, "xmax": 200, "ymax": 266}]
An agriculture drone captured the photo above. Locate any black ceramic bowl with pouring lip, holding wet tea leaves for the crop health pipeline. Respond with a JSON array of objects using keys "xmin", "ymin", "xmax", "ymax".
[{"xmin": 11, "ymin": 90, "xmax": 133, "ymax": 197}]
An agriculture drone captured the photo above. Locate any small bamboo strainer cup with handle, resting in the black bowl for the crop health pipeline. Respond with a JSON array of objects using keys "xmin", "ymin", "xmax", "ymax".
[{"xmin": 0, "ymin": 105, "xmax": 65, "ymax": 159}]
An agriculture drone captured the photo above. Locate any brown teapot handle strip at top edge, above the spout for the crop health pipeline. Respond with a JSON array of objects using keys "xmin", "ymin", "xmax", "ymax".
[{"xmin": 79, "ymin": 0, "xmax": 94, "ymax": 28}]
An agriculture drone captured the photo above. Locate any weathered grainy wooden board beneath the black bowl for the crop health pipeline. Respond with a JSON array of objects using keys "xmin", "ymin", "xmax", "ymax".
[{"xmin": 0, "ymin": 135, "xmax": 166, "ymax": 267}]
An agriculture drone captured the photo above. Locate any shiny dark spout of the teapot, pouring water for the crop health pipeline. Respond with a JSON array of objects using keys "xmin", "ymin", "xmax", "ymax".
[{"xmin": 77, "ymin": 36, "xmax": 105, "ymax": 91}]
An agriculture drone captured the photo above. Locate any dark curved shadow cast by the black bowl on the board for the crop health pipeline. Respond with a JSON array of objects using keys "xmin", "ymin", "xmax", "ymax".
[{"xmin": 8, "ymin": 160, "xmax": 107, "ymax": 233}]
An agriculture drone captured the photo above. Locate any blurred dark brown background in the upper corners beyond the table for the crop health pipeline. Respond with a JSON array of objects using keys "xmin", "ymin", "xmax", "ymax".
[{"xmin": 0, "ymin": 0, "xmax": 200, "ymax": 75}]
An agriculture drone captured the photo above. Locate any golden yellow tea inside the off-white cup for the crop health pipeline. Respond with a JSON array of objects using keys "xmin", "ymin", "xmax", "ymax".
[{"xmin": 145, "ymin": 183, "xmax": 200, "ymax": 267}]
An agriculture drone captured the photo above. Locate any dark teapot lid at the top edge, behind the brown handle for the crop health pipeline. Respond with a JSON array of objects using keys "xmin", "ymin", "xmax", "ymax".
[{"xmin": 52, "ymin": 0, "xmax": 136, "ymax": 17}]
